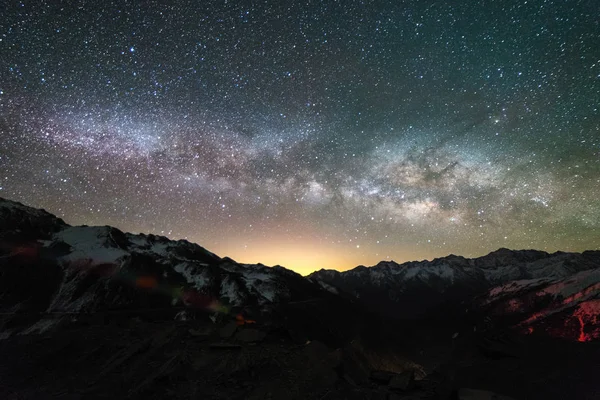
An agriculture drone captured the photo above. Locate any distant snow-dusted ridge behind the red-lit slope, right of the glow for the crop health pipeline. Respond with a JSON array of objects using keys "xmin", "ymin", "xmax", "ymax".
[{"xmin": 309, "ymin": 249, "xmax": 600, "ymax": 317}]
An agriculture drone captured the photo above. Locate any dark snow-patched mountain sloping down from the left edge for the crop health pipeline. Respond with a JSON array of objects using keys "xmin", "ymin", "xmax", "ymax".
[{"xmin": 0, "ymin": 199, "xmax": 331, "ymax": 331}]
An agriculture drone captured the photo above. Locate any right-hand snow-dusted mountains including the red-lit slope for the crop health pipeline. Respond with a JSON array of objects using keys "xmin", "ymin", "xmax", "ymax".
[{"xmin": 308, "ymin": 248, "xmax": 600, "ymax": 341}]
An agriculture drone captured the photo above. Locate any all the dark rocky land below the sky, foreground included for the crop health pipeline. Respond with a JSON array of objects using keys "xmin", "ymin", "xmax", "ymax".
[{"xmin": 0, "ymin": 199, "xmax": 600, "ymax": 400}]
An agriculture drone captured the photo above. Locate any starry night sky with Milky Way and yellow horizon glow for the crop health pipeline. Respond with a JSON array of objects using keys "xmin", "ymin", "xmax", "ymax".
[{"xmin": 0, "ymin": 0, "xmax": 600, "ymax": 274}]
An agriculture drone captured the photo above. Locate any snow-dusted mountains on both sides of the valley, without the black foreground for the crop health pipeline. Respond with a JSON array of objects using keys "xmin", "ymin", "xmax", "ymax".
[{"xmin": 0, "ymin": 195, "xmax": 600, "ymax": 341}]
